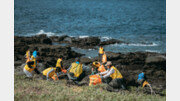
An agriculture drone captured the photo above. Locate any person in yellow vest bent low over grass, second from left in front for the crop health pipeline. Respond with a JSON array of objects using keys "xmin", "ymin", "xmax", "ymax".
[{"xmin": 42, "ymin": 67, "xmax": 58, "ymax": 80}]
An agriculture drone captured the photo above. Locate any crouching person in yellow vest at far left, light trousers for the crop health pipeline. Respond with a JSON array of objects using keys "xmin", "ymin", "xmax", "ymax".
[{"xmin": 23, "ymin": 59, "xmax": 40, "ymax": 77}]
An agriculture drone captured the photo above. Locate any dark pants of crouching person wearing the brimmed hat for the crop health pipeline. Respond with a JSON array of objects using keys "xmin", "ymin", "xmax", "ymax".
[{"xmin": 107, "ymin": 78, "xmax": 126, "ymax": 91}]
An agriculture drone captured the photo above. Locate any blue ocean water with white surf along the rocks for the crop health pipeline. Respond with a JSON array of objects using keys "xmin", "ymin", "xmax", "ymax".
[{"xmin": 14, "ymin": 0, "xmax": 166, "ymax": 54}]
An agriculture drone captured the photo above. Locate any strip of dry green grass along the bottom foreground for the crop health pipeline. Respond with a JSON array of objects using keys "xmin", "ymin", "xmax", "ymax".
[{"xmin": 14, "ymin": 75, "xmax": 166, "ymax": 101}]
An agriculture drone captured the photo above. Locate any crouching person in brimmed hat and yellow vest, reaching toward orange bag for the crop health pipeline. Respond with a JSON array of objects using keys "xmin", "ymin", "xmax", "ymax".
[{"xmin": 99, "ymin": 61, "xmax": 126, "ymax": 91}]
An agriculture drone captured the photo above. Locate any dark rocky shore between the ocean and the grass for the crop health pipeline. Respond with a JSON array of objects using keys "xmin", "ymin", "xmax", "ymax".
[{"xmin": 14, "ymin": 34, "xmax": 166, "ymax": 94}]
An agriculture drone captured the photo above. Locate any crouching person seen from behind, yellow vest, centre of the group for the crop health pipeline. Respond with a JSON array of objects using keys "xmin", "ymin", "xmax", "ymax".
[{"xmin": 67, "ymin": 58, "xmax": 85, "ymax": 83}]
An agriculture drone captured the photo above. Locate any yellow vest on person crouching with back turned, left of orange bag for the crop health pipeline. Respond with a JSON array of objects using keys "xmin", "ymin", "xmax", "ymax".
[{"xmin": 70, "ymin": 63, "xmax": 83, "ymax": 77}]
